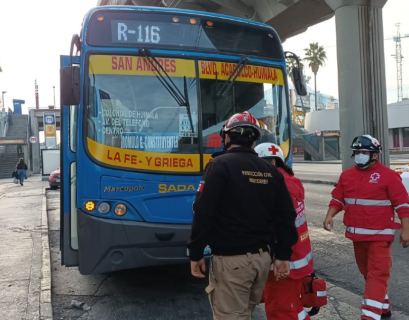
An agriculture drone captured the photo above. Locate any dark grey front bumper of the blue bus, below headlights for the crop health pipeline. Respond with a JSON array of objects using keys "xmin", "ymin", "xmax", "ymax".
[{"xmin": 77, "ymin": 210, "xmax": 191, "ymax": 275}]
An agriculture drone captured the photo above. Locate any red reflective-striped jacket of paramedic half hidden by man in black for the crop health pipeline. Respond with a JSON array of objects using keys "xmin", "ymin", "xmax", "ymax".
[{"xmin": 278, "ymin": 168, "xmax": 314, "ymax": 279}]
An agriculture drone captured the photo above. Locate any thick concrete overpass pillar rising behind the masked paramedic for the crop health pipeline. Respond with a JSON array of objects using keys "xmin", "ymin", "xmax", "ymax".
[{"xmin": 325, "ymin": 0, "xmax": 389, "ymax": 170}]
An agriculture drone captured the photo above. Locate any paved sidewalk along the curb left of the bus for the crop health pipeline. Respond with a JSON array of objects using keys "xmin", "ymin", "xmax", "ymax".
[{"xmin": 0, "ymin": 175, "xmax": 52, "ymax": 320}]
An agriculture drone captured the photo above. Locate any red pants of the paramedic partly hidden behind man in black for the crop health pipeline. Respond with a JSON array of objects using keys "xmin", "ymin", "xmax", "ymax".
[{"xmin": 263, "ymin": 271, "xmax": 310, "ymax": 320}]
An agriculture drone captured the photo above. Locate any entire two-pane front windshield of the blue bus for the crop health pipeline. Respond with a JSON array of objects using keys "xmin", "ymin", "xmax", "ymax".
[{"xmin": 86, "ymin": 55, "xmax": 289, "ymax": 173}]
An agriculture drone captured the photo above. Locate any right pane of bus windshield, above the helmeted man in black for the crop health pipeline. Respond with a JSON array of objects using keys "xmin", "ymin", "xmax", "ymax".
[{"xmin": 198, "ymin": 61, "xmax": 290, "ymax": 157}]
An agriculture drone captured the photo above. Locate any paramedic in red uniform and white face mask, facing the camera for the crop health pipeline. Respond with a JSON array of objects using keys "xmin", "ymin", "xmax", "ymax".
[{"xmin": 324, "ymin": 135, "xmax": 409, "ymax": 320}]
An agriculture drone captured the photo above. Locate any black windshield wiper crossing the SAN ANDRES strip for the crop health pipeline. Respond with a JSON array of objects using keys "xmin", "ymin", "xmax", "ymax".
[{"xmin": 139, "ymin": 48, "xmax": 194, "ymax": 133}]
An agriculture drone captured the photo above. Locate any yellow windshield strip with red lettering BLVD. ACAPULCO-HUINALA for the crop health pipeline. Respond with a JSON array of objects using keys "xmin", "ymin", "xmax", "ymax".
[{"xmin": 199, "ymin": 60, "xmax": 284, "ymax": 85}]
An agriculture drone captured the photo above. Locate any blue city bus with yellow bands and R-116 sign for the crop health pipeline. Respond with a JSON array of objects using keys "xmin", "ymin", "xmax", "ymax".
[{"xmin": 60, "ymin": 6, "xmax": 304, "ymax": 274}]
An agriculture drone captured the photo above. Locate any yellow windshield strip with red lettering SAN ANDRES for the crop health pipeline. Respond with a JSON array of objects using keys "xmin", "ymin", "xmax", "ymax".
[{"xmin": 89, "ymin": 55, "xmax": 196, "ymax": 78}]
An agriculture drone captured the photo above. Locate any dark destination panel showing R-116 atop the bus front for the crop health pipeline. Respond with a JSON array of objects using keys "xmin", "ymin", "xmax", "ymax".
[{"xmin": 86, "ymin": 11, "xmax": 283, "ymax": 60}]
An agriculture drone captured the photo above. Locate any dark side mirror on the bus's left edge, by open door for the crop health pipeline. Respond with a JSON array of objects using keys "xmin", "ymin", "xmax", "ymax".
[{"xmin": 60, "ymin": 66, "xmax": 81, "ymax": 106}]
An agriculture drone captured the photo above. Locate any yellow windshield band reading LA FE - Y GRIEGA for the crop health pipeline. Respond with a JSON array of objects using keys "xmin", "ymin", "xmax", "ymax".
[{"xmin": 87, "ymin": 138, "xmax": 200, "ymax": 173}]
